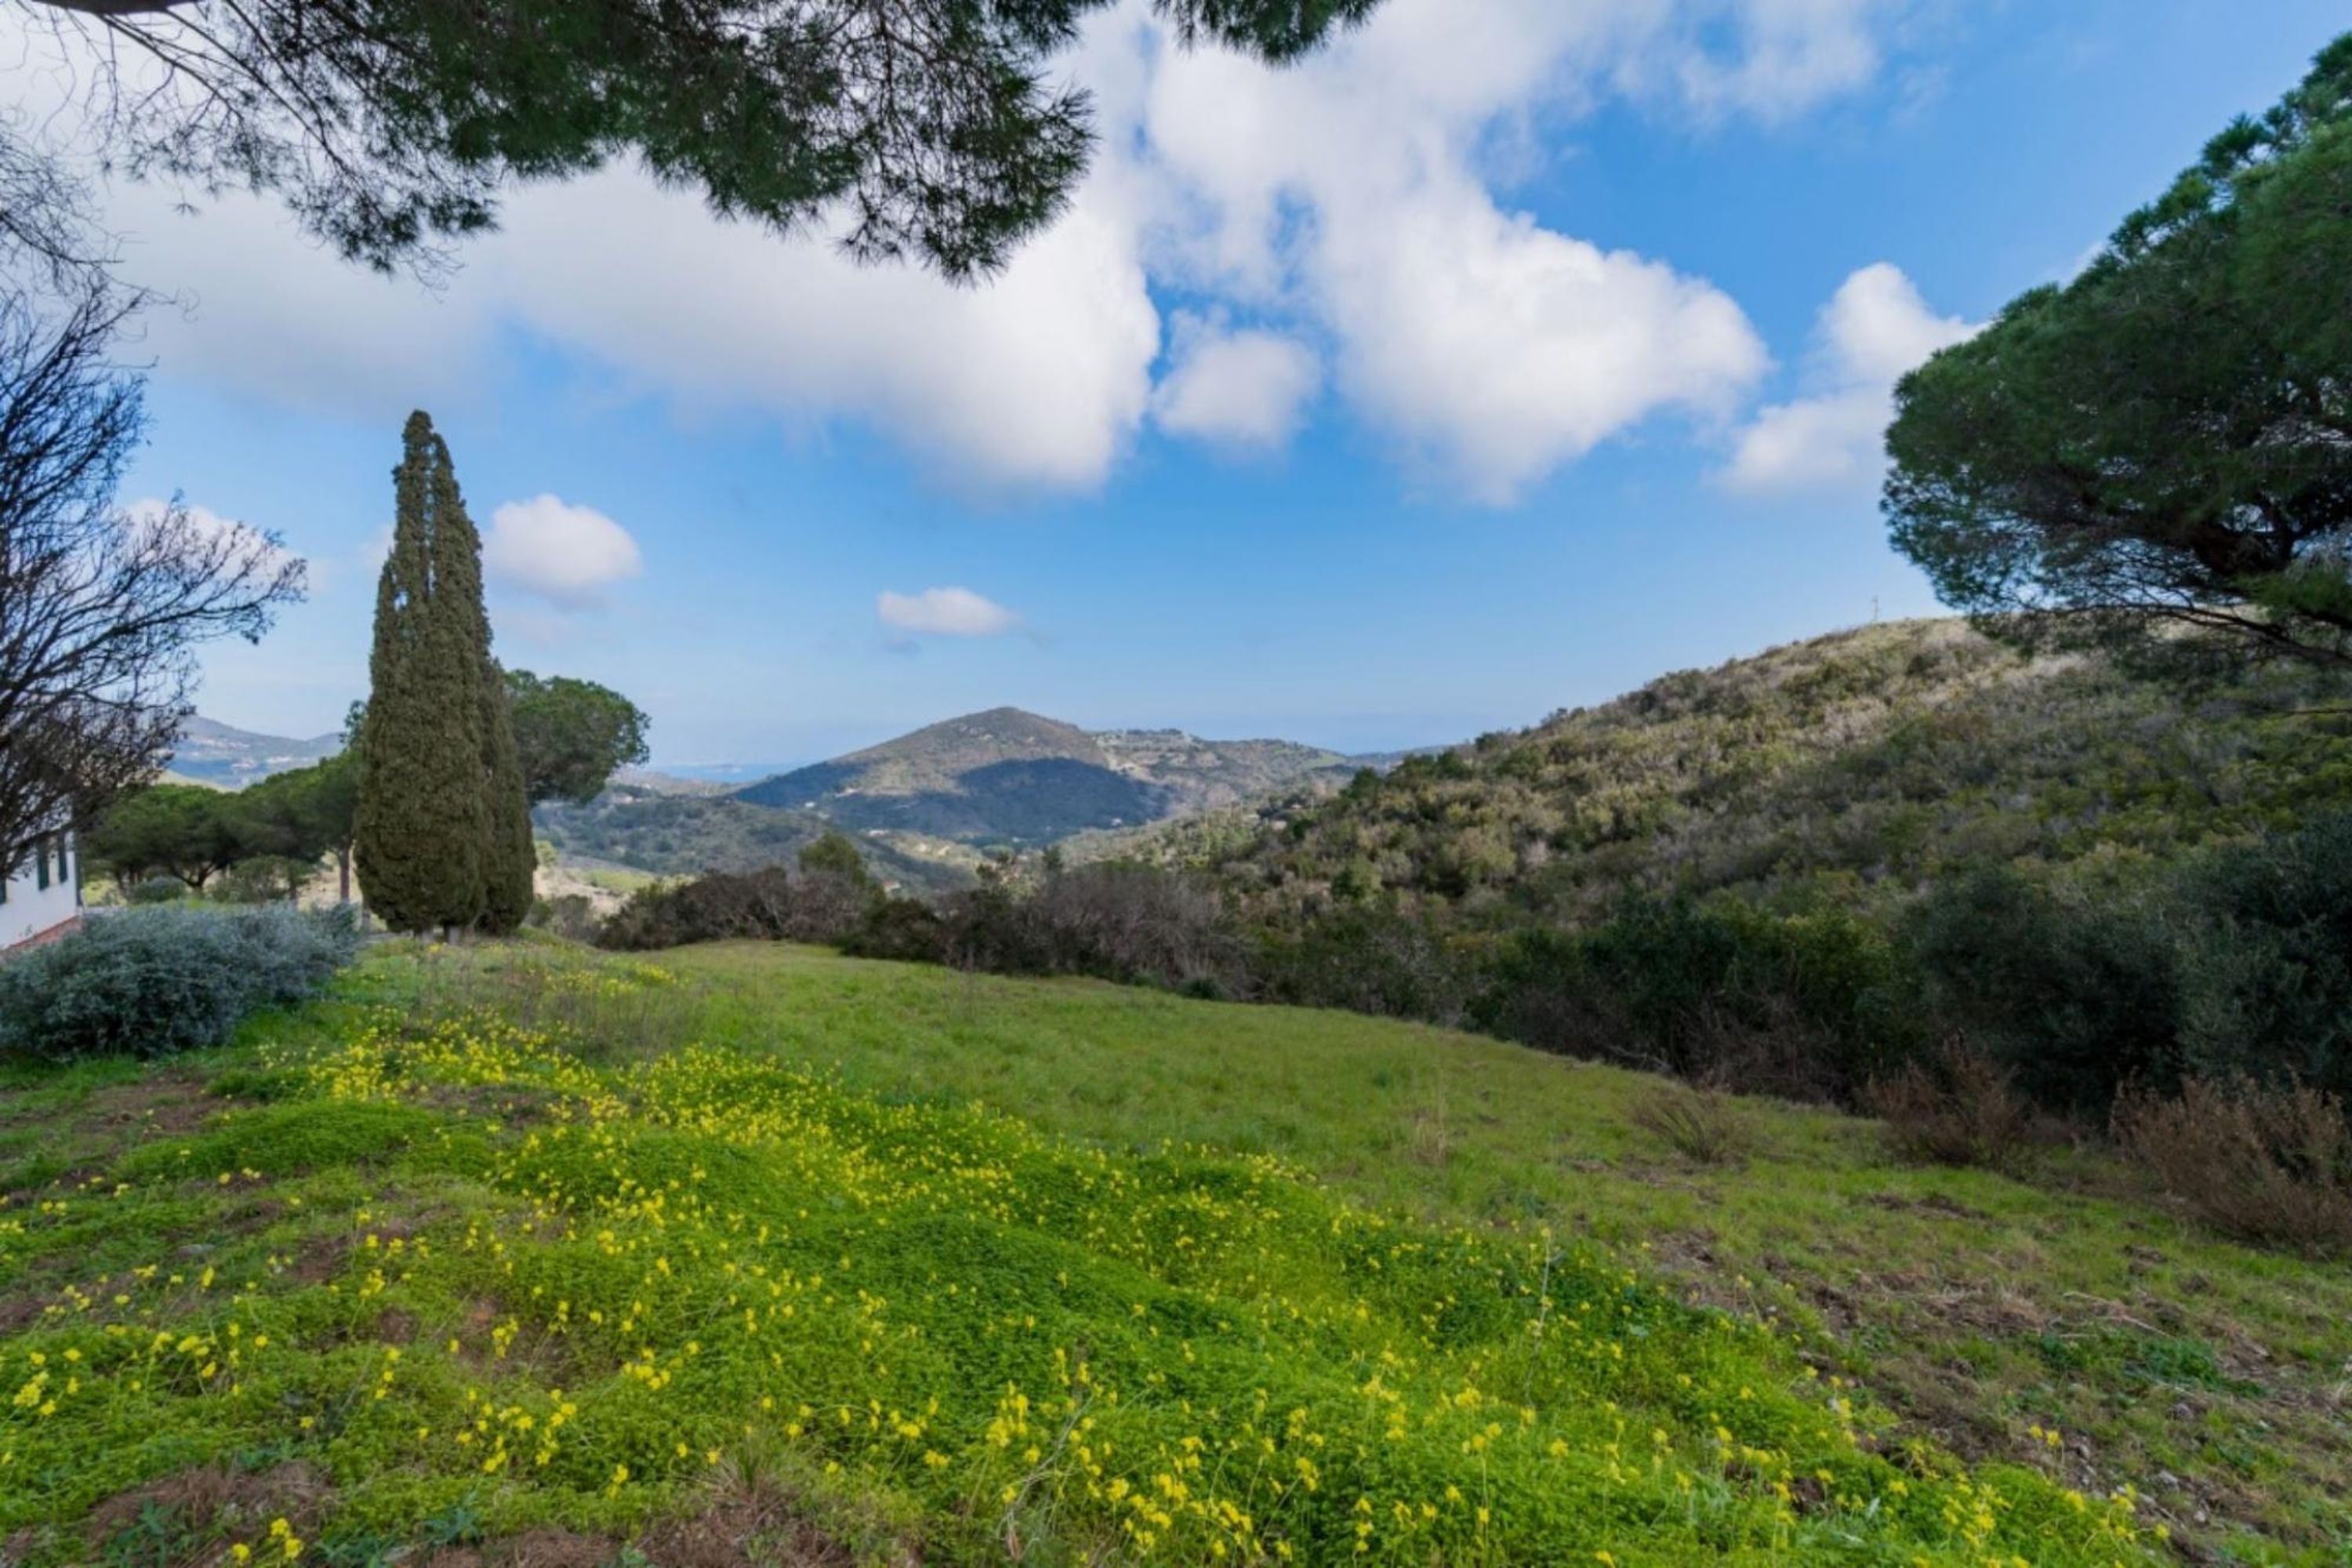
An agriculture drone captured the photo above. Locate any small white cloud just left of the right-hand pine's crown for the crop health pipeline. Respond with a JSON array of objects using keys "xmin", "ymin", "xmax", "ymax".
[{"xmin": 1719, "ymin": 261, "xmax": 1976, "ymax": 494}]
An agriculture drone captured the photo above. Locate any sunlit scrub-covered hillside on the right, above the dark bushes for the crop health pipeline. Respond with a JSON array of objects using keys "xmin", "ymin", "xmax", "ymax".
[{"xmin": 1185, "ymin": 621, "xmax": 2352, "ymax": 924}]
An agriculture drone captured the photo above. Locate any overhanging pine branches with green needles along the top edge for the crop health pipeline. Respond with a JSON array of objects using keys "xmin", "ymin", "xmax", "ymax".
[{"xmin": 31, "ymin": 0, "xmax": 1378, "ymax": 278}]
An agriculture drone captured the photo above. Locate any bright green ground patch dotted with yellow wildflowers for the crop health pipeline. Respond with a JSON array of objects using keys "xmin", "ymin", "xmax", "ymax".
[{"xmin": 0, "ymin": 966, "xmax": 2150, "ymax": 1566}]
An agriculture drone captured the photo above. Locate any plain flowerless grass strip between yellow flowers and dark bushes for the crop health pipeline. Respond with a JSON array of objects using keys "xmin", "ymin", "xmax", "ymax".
[{"xmin": 649, "ymin": 945, "xmax": 2352, "ymax": 1561}]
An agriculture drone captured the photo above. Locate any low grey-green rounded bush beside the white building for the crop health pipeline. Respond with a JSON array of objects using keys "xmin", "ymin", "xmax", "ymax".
[{"xmin": 0, "ymin": 905, "xmax": 360, "ymax": 1058}]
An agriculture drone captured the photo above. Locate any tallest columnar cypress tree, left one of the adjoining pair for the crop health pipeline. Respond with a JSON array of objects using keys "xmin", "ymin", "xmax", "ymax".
[{"xmin": 353, "ymin": 412, "xmax": 492, "ymax": 931}]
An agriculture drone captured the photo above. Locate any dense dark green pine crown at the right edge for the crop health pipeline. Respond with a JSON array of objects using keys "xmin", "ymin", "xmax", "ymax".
[{"xmin": 1886, "ymin": 35, "xmax": 2352, "ymax": 666}]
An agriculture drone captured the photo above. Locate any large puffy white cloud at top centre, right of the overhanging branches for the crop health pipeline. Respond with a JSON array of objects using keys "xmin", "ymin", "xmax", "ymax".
[{"xmin": 1143, "ymin": 0, "xmax": 1766, "ymax": 503}]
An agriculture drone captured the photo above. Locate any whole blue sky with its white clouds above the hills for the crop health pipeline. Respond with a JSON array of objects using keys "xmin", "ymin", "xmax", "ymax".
[{"xmin": 82, "ymin": 0, "xmax": 2352, "ymax": 764}]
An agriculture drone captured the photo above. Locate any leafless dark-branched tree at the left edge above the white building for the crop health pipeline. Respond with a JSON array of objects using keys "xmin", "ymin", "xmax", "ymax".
[{"xmin": 0, "ymin": 275, "xmax": 303, "ymax": 865}]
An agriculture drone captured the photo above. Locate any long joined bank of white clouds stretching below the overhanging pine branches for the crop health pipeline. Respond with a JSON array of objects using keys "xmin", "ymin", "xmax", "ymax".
[{"xmin": 18, "ymin": 0, "xmax": 1922, "ymax": 501}]
